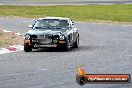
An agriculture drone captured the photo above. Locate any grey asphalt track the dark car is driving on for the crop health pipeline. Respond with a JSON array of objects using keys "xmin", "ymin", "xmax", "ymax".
[{"xmin": 0, "ymin": 17, "xmax": 132, "ymax": 88}]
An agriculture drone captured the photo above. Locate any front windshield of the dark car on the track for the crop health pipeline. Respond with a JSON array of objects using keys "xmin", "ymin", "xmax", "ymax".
[{"xmin": 33, "ymin": 19, "xmax": 68, "ymax": 29}]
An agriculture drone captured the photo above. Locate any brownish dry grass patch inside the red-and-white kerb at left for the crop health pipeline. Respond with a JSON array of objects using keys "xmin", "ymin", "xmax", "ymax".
[{"xmin": 0, "ymin": 31, "xmax": 23, "ymax": 48}]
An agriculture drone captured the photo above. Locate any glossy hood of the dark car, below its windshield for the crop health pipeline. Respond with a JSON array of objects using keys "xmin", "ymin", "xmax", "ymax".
[{"xmin": 26, "ymin": 29, "xmax": 68, "ymax": 35}]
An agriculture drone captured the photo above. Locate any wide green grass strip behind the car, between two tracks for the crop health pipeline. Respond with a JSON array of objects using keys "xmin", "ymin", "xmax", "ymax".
[{"xmin": 0, "ymin": 4, "xmax": 132, "ymax": 22}]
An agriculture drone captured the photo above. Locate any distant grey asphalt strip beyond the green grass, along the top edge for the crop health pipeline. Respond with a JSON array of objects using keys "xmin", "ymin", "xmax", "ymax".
[{"xmin": 0, "ymin": 0, "xmax": 132, "ymax": 5}]
